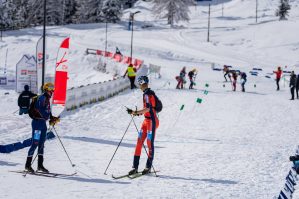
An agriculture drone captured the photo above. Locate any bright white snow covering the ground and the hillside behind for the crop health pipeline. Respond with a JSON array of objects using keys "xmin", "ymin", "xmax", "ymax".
[{"xmin": 0, "ymin": 0, "xmax": 299, "ymax": 199}]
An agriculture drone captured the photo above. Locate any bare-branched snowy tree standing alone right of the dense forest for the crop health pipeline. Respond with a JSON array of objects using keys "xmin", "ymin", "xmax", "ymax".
[{"xmin": 153, "ymin": 0, "xmax": 195, "ymax": 26}]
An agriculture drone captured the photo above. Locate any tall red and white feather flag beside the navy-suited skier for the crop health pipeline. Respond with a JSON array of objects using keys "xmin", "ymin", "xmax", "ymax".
[{"xmin": 52, "ymin": 38, "xmax": 70, "ymax": 116}]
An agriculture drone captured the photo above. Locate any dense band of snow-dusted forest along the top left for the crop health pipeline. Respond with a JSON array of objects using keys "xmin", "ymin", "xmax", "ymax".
[{"xmin": 0, "ymin": 0, "xmax": 136, "ymax": 29}]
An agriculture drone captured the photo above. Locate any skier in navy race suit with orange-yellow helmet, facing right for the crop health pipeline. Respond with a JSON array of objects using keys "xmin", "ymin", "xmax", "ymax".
[{"xmin": 25, "ymin": 82, "xmax": 60, "ymax": 173}]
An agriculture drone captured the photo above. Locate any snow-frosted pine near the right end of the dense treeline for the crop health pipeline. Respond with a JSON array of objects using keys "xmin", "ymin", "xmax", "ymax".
[{"xmin": 101, "ymin": 0, "xmax": 123, "ymax": 23}]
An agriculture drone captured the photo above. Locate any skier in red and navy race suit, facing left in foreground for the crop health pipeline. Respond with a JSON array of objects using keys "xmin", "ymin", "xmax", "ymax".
[{"xmin": 127, "ymin": 76, "xmax": 159, "ymax": 175}]
